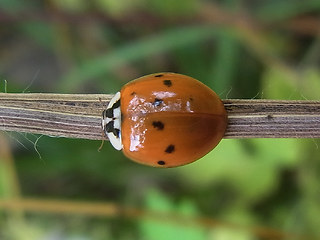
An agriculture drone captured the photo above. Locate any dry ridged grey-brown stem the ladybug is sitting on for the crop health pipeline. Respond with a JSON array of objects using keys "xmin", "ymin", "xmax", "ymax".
[{"xmin": 0, "ymin": 93, "xmax": 320, "ymax": 140}]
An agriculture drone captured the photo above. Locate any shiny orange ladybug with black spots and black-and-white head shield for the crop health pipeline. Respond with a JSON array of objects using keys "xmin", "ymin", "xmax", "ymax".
[{"xmin": 102, "ymin": 73, "xmax": 227, "ymax": 167}]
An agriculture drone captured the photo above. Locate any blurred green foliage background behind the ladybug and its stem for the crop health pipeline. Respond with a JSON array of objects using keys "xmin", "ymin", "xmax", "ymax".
[{"xmin": 0, "ymin": 0, "xmax": 320, "ymax": 240}]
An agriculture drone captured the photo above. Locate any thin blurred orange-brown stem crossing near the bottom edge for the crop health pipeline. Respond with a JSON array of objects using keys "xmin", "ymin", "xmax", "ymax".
[{"xmin": 0, "ymin": 198, "xmax": 312, "ymax": 240}]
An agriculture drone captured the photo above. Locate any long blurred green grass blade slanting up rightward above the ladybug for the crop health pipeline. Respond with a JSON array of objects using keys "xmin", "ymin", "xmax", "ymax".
[{"xmin": 59, "ymin": 26, "xmax": 222, "ymax": 91}]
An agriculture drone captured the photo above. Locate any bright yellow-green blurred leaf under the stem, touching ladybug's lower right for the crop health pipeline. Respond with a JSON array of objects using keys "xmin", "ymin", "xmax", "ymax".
[{"xmin": 177, "ymin": 139, "xmax": 300, "ymax": 202}]
